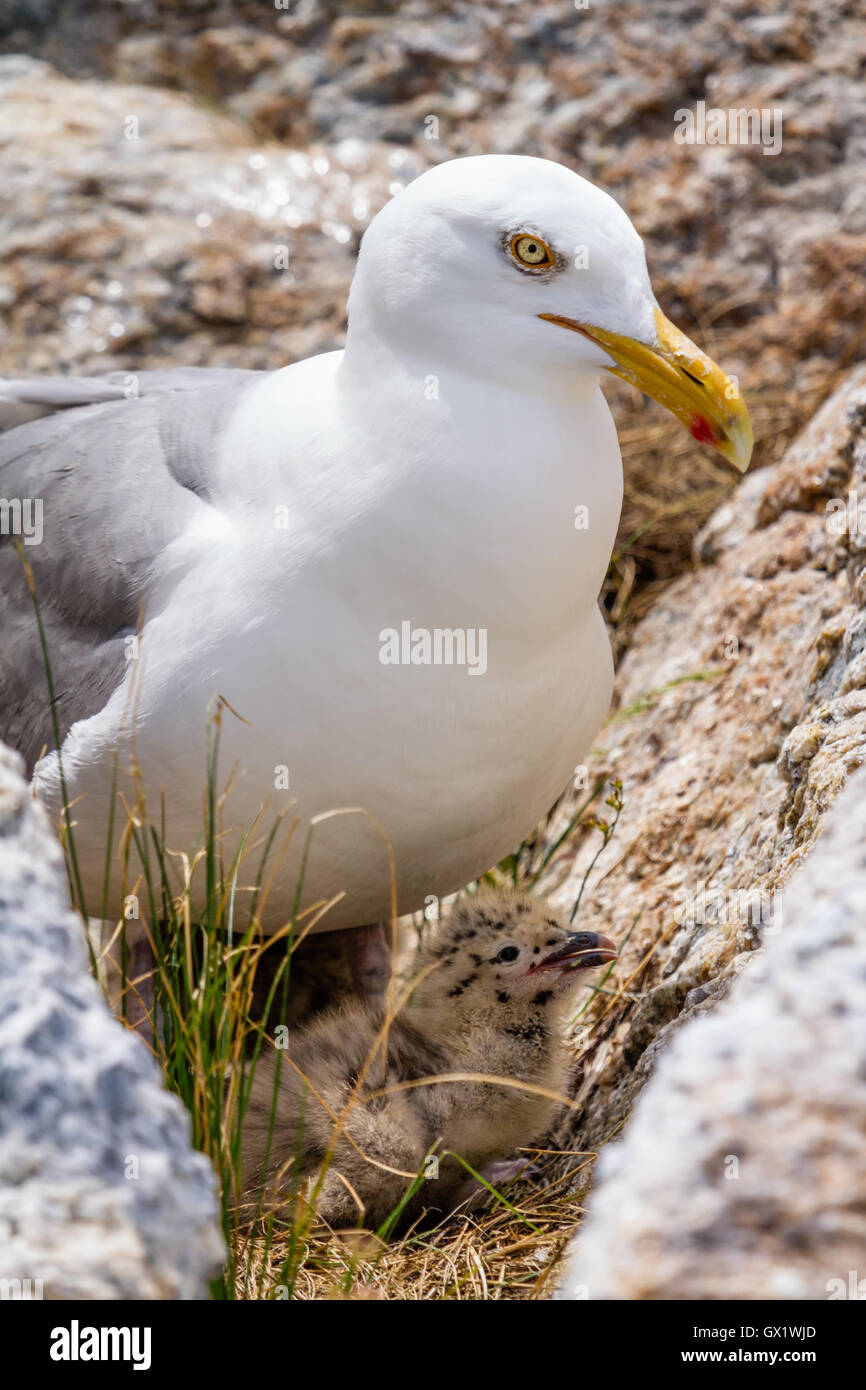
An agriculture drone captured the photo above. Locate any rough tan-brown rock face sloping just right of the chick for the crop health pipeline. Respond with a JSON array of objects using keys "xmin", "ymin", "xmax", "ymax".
[{"xmin": 539, "ymin": 366, "xmax": 866, "ymax": 1173}]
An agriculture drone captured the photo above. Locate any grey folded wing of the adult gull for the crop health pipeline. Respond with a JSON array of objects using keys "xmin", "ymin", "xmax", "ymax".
[{"xmin": 0, "ymin": 368, "xmax": 260, "ymax": 767}]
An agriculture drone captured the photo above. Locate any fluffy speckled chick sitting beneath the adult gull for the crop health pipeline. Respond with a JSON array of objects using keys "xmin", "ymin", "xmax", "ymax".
[{"xmin": 242, "ymin": 892, "xmax": 616, "ymax": 1229}]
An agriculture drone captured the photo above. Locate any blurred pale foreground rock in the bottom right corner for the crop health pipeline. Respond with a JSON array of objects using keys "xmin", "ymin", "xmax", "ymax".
[{"xmin": 559, "ymin": 771, "xmax": 866, "ymax": 1300}]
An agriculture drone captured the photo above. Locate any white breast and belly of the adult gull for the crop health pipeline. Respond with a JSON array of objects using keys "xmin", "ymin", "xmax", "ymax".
[{"xmin": 39, "ymin": 354, "xmax": 621, "ymax": 927}]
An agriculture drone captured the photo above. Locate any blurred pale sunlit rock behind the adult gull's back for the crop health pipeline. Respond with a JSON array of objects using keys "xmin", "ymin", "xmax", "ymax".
[{"xmin": 0, "ymin": 57, "xmax": 421, "ymax": 377}]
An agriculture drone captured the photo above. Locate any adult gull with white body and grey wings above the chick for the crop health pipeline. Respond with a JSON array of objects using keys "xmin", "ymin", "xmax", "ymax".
[{"xmin": 0, "ymin": 156, "xmax": 752, "ymax": 933}]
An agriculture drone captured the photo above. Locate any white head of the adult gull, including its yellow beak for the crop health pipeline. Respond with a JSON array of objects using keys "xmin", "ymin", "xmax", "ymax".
[{"xmin": 348, "ymin": 154, "xmax": 751, "ymax": 467}]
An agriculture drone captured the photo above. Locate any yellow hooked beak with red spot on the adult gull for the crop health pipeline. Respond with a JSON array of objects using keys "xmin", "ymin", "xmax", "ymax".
[{"xmin": 538, "ymin": 309, "xmax": 752, "ymax": 473}]
